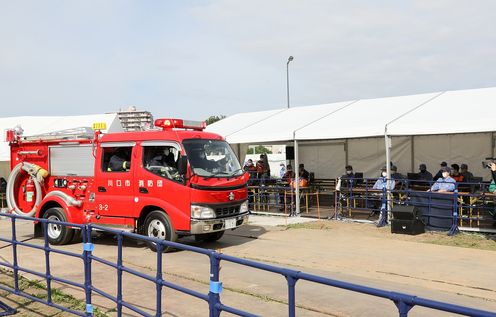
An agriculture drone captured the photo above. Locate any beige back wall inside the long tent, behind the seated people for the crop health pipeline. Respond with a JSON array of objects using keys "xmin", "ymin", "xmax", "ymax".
[{"xmin": 232, "ymin": 133, "xmax": 496, "ymax": 180}]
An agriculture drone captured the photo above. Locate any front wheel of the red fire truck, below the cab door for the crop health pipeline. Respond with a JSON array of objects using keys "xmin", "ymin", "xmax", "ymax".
[{"xmin": 143, "ymin": 210, "xmax": 177, "ymax": 252}]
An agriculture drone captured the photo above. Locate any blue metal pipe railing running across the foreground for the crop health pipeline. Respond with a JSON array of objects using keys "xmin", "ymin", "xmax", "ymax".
[{"xmin": 0, "ymin": 215, "xmax": 496, "ymax": 317}]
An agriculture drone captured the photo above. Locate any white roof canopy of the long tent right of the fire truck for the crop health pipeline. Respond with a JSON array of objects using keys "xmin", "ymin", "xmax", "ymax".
[{"xmin": 207, "ymin": 87, "xmax": 496, "ymax": 144}]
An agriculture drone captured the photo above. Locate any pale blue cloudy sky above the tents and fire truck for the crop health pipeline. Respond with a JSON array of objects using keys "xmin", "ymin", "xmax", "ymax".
[{"xmin": 0, "ymin": 0, "xmax": 496, "ymax": 120}]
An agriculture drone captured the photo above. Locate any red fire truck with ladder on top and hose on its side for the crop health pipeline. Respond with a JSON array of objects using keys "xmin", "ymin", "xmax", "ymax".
[{"xmin": 7, "ymin": 119, "xmax": 249, "ymax": 249}]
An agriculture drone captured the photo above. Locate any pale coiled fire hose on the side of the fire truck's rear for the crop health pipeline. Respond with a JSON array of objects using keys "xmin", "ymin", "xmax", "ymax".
[{"xmin": 6, "ymin": 162, "xmax": 48, "ymax": 217}]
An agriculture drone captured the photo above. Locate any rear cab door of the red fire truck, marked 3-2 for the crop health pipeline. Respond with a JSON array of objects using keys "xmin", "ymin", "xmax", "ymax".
[{"xmin": 94, "ymin": 142, "xmax": 136, "ymax": 218}]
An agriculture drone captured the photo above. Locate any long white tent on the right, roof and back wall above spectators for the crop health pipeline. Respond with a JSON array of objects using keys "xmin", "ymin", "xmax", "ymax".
[{"xmin": 207, "ymin": 88, "xmax": 496, "ymax": 179}]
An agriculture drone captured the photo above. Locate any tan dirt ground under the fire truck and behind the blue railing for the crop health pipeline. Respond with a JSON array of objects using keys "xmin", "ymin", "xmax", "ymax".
[{"xmin": 0, "ymin": 217, "xmax": 496, "ymax": 317}]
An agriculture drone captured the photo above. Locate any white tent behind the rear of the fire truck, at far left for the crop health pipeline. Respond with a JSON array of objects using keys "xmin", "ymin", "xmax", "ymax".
[{"xmin": 0, "ymin": 113, "xmax": 123, "ymax": 178}]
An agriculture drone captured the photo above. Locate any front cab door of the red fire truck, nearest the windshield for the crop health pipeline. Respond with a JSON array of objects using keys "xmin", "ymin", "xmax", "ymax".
[{"xmin": 140, "ymin": 141, "xmax": 190, "ymax": 230}]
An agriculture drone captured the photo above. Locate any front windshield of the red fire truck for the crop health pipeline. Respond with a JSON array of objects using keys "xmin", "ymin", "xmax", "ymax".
[{"xmin": 183, "ymin": 139, "xmax": 244, "ymax": 177}]
